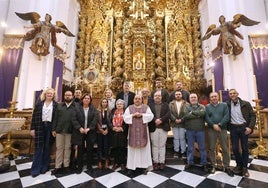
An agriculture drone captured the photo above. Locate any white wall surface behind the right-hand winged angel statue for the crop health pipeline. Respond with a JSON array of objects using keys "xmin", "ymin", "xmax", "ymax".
[{"xmin": 199, "ymin": 0, "xmax": 268, "ymax": 104}]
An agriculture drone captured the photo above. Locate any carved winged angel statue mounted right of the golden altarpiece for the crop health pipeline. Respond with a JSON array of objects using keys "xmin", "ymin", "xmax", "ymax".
[{"xmin": 202, "ymin": 14, "xmax": 260, "ymax": 55}]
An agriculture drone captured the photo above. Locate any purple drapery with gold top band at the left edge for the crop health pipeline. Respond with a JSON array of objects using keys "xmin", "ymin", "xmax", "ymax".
[{"xmin": 0, "ymin": 35, "xmax": 24, "ymax": 108}]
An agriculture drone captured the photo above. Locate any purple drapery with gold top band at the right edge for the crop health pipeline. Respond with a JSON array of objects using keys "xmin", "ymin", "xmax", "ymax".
[{"xmin": 249, "ymin": 35, "xmax": 268, "ymax": 108}]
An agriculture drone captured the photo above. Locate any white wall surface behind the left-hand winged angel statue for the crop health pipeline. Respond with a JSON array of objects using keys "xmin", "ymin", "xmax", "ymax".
[{"xmin": 1, "ymin": 0, "xmax": 79, "ymax": 109}]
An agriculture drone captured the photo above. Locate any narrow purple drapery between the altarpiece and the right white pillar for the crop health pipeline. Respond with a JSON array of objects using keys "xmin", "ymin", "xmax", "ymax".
[{"xmin": 212, "ymin": 50, "xmax": 224, "ymax": 92}]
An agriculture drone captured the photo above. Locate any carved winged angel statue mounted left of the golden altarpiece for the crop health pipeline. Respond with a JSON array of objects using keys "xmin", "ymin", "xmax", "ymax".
[{"xmin": 15, "ymin": 12, "xmax": 74, "ymax": 58}]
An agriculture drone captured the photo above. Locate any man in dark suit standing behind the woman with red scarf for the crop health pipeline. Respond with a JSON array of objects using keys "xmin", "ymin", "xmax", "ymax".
[{"xmin": 116, "ymin": 81, "xmax": 135, "ymax": 109}]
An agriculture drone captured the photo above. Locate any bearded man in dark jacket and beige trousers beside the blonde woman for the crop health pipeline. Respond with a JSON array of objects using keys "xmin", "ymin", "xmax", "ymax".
[{"xmin": 51, "ymin": 91, "xmax": 78, "ymax": 175}]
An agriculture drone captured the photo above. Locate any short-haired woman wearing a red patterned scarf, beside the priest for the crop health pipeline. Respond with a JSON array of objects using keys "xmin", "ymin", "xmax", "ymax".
[{"xmin": 111, "ymin": 99, "xmax": 128, "ymax": 171}]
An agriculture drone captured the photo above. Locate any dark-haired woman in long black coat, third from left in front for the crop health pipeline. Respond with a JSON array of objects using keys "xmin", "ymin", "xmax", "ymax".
[{"xmin": 71, "ymin": 93, "xmax": 98, "ymax": 173}]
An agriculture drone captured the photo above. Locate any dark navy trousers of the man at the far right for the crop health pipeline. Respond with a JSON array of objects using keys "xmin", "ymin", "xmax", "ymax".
[{"xmin": 231, "ymin": 125, "xmax": 249, "ymax": 168}]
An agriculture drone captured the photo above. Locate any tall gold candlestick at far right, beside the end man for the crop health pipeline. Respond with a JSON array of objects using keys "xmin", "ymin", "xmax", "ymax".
[{"xmin": 251, "ymin": 99, "xmax": 268, "ymax": 158}]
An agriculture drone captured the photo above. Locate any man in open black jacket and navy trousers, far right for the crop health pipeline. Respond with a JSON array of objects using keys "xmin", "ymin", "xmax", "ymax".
[{"xmin": 227, "ymin": 89, "xmax": 256, "ymax": 177}]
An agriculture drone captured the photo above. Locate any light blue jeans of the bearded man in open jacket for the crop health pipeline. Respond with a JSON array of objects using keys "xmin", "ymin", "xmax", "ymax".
[{"xmin": 172, "ymin": 127, "xmax": 186, "ymax": 153}]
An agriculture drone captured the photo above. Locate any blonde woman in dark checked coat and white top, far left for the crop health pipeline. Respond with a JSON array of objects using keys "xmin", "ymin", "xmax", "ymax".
[{"xmin": 30, "ymin": 88, "xmax": 57, "ymax": 177}]
